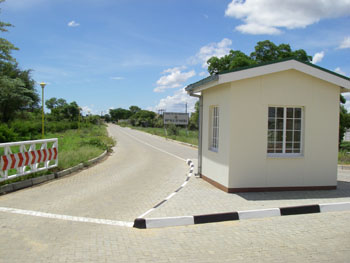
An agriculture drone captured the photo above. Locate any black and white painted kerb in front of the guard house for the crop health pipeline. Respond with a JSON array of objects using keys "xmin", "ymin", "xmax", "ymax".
[{"xmin": 134, "ymin": 202, "xmax": 350, "ymax": 229}]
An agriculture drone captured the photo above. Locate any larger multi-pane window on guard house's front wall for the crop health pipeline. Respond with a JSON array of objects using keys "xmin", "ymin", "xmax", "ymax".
[{"xmin": 267, "ymin": 107, "xmax": 303, "ymax": 156}]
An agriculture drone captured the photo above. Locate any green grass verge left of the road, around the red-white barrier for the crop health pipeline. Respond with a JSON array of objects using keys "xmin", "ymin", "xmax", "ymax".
[{"xmin": 0, "ymin": 125, "xmax": 115, "ymax": 186}]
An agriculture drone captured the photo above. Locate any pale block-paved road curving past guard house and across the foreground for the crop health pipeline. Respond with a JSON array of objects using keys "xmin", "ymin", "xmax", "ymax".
[{"xmin": 0, "ymin": 125, "xmax": 350, "ymax": 263}]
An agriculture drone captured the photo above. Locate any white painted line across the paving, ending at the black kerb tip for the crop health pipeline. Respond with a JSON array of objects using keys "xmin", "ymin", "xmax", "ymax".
[{"xmin": 0, "ymin": 207, "xmax": 134, "ymax": 227}]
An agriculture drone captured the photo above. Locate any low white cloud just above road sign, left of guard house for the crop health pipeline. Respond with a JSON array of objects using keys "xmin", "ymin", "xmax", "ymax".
[{"xmin": 154, "ymin": 88, "xmax": 198, "ymax": 112}]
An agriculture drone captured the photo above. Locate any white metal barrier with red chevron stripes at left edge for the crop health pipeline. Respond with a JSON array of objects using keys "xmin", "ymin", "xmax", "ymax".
[{"xmin": 0, "ymin": 138, "xmax": 58, "ymax": 182}]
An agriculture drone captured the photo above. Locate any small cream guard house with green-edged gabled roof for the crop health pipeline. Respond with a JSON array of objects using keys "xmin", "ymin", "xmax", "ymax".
[{"xmin": 186, "ymin": 59, "xmax": 350, "ymax": 192}]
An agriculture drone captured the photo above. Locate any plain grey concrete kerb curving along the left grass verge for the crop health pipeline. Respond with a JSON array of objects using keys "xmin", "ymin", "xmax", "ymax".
[{"xmin": 0, "ymin": 151, "xmax": 107, "ymax": 195}]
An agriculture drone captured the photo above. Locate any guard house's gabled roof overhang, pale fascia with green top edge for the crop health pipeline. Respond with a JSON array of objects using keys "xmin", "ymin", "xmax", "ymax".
[{"xmin": 186, "ymin": 59, "xmax": 350, "ymax": 94}]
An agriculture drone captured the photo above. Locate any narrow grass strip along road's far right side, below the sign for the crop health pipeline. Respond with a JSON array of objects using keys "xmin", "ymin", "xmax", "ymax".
[{"xmin": 120, "ymin": 124, "xmax": 198, "ymax": 145}]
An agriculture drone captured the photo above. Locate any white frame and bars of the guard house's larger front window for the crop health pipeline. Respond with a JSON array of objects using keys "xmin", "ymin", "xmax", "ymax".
[{"xmin": 266, "ymin": 105, "xmax": 305, "ymax": 158}]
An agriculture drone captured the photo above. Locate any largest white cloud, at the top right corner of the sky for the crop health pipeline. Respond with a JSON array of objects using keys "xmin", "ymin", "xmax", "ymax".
[{"xmin": 225, "ymin": 0, "xmax": 350, "ymax": 35}]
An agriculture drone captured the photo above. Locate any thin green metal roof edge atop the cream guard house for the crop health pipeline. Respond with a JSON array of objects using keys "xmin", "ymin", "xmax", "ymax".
[{"xmin": 185, "ymin": 58, "xmax": 350, "ymax": 91}]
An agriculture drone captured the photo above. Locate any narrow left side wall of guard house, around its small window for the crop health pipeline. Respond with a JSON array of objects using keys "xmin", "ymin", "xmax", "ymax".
[{"xmin": 202, "ymin": 84, "xmax": 230, "ymax": 187}]
